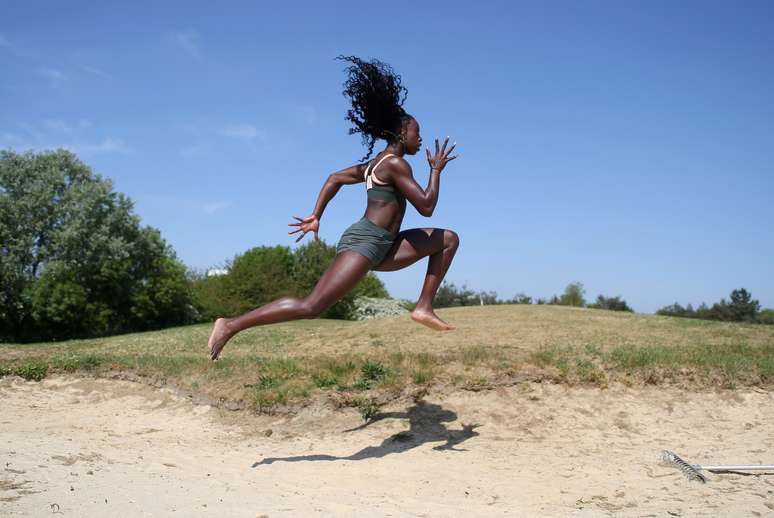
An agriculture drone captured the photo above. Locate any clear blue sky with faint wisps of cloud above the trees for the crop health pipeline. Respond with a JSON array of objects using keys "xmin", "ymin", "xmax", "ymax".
[{"xmin": 0, "ymin": 0, "xmax": 774, "ymax": 312}]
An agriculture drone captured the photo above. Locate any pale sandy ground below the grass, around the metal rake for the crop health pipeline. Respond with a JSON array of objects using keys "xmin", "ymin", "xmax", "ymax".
[{"xmin": 0, "ymin": 377, "xmax": 774, "ymax": 518}]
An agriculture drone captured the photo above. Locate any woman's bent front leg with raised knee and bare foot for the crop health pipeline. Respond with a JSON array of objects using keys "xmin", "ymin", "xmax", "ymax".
[{"xmin": 374, "ymin": 228, "xmax": 460, "ymax": 331}]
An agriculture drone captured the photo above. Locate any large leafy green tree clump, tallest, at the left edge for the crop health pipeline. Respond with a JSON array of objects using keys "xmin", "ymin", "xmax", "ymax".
[{"xmin": 0, "ymin": 150, "xmax": 195, "ymax": 341}]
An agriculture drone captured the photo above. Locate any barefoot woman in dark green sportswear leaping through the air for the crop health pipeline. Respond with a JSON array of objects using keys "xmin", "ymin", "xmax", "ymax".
[{"xmin": 208, "ymin": 56, "xmax": 459, "ymax": 360}]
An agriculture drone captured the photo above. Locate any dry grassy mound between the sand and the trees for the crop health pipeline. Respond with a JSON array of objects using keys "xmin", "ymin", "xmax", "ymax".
[{"xmin": 0, "ymin": 305, "xmax": 774, "ymax": 411}]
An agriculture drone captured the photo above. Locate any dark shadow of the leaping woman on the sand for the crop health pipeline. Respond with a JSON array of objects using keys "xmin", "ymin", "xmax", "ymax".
[{"xmin": 252, "ymin": 401, "xmax": 480, "ymax": 468}]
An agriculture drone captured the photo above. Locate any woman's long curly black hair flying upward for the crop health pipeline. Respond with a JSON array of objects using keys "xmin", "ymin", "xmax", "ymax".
[{"xmin": 336, "ymin": 56, "xmax": 413, "ymax": 160}]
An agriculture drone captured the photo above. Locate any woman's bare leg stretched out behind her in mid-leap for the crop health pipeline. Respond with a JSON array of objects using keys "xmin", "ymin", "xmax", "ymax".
[{"xmin": 208, "ymin": 251, "xmax": 372, "ymax": 360}]
